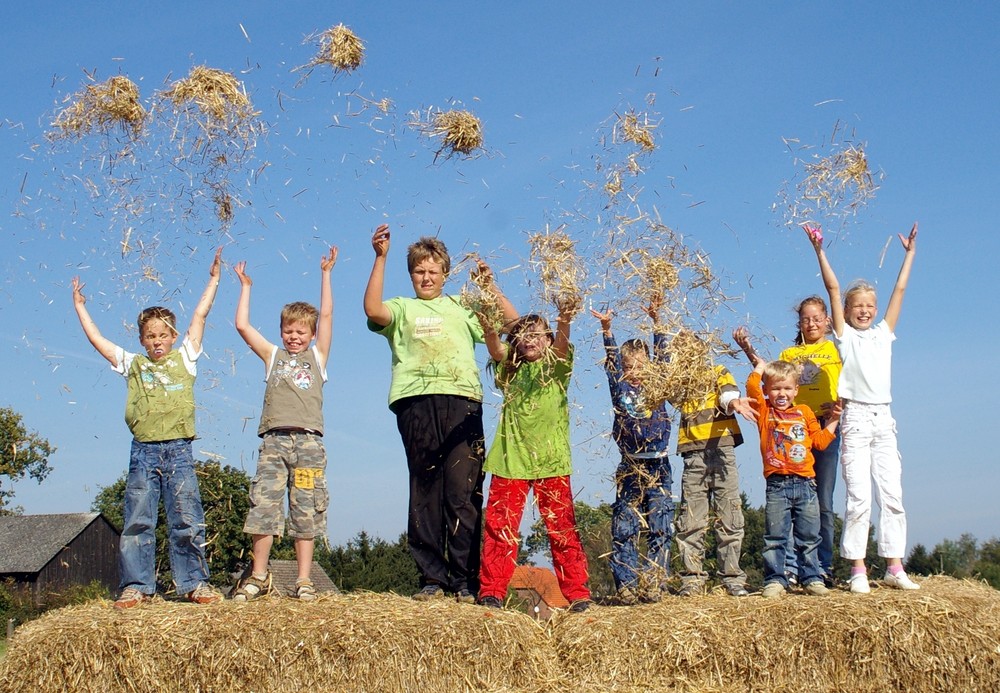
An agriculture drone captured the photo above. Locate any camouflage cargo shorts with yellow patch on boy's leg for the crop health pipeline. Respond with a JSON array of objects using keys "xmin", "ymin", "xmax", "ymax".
[{"xmin": 243, "ymin": 431, "xmax": 330, "ymax": 539}]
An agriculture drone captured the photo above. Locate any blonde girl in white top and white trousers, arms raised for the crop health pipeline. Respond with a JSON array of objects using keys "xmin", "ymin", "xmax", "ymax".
[{"xmin": 805, "ymin": 223, "xmax": 920, "ymax": 594}]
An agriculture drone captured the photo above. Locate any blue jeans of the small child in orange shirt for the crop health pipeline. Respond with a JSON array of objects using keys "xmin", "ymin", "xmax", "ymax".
[{"xmin": 763, "ymin": 474, "xmax": 822, "ymax": 587}]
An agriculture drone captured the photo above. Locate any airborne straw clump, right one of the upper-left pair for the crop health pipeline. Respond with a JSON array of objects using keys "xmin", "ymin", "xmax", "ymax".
[{"xmin": 162, "ymin": 65, "xmax": 259, "ymax": 132}]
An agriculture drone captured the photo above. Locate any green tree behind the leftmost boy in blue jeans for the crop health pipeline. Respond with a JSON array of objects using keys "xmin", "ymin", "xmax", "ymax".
[{"xmin": 91, "ymin": 462, "xmax": 254, "ymax": 585}]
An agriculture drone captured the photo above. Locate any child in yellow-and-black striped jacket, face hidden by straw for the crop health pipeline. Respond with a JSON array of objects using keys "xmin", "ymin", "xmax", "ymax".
[{"xmin": 672, "ymin": 344, "xmax": 755, "ymax": 597}]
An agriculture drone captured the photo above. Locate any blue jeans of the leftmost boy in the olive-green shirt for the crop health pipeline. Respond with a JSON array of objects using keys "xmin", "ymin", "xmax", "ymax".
[{"xmin": 118, "ymin": 440, "xmax": 208, "ymax": 594}]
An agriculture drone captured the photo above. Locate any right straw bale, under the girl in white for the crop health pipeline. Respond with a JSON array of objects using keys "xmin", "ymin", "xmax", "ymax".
[{"xmin": 552, "ymin": 577, "xmax": 1000, "ymax": 692}]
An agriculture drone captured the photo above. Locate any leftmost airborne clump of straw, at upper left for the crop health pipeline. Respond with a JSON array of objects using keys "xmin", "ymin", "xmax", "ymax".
[{"xmin": 49, "ymin": 75, "xmax": 146, "ymax": 139}]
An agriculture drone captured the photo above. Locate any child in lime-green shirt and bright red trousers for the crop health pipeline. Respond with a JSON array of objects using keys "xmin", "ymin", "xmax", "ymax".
[{"xmin": 479, "ymin": 302, "xmax": 591, "ymax": 612}]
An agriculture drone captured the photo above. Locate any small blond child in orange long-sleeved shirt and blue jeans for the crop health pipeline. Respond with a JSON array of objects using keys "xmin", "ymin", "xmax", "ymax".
[{"xmin": 747, "ymin": 361, "xmax": 840, "ymax": 598}]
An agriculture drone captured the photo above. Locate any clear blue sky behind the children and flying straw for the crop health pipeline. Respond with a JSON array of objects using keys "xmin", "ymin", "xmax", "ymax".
[{"xmin": 0, "ymin": 2, "xmax": 1000, "ymax": 546}]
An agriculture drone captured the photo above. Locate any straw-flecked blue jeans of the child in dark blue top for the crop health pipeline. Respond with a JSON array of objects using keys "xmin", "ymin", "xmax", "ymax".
[{"xmin": 611, "ymin": 455, "xmax": 674, "ymax": 589}]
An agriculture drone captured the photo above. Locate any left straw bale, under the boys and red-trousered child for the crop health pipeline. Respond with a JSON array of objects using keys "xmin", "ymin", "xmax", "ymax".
[{"xmin": 0, "ymin": 594, "xmax": 557, "ymax": 693}]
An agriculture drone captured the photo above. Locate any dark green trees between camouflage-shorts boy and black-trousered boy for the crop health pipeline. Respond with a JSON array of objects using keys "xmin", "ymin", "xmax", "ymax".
[{"xmin": 316, "ymin": 531, "xmax": 420, "ymax": 596}]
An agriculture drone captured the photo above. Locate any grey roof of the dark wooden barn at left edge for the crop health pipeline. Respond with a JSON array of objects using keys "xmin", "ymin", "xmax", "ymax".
[{"xmin": 0, "ymin": 513, "xmax": 108, "ymax": 573}]
